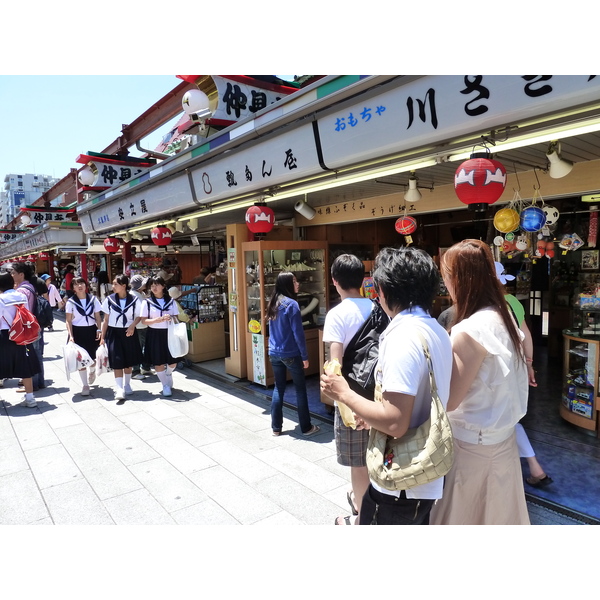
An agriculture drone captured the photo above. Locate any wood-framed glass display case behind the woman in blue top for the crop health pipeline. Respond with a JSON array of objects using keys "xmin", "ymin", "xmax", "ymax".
[{"xmin": 242, "ymin": 241, "xmax": 327, "ymax": 386}]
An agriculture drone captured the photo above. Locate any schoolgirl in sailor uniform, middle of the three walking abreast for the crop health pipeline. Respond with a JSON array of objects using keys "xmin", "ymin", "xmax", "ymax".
[{"xmin": 100, "ymin": 275, "xmax": 142, "ymax": 404}]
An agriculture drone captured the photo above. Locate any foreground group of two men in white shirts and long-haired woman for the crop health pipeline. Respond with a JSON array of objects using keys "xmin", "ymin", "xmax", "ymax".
[{"xmin": 321, "ymin": 240, "xmax": 535, "ymax": 525}]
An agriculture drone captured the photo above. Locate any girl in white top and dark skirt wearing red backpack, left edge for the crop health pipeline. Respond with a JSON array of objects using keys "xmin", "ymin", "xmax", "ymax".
[{"xmin": 0, "ymin": 273, "xmax": 40, "ymax": 408}]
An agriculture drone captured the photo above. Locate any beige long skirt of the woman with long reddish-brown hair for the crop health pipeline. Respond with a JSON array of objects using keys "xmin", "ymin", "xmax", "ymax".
[{"xmin": 430, "ymin": 434, "xmax": 530, "ymax": 525}]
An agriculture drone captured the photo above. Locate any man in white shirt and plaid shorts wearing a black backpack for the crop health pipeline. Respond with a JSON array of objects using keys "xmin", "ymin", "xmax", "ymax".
[{"xmin": 323, "ymin": 254, "xmax": 373, "ymax": 525}]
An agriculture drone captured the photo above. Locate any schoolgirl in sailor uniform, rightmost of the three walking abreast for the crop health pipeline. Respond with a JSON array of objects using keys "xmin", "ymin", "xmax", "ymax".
[{"xmin": 142, "ymin": 277, "xmax": 181, "ymax": 397}]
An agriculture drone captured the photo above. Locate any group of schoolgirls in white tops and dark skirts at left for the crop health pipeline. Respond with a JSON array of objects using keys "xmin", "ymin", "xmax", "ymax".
[{"xmin": 0, "ymin": 262, "xmax": 188, "ymax": 408}]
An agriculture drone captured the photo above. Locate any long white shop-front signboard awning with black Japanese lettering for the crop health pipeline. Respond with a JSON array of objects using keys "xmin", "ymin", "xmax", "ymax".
[{"xmin": 78, "ymin": 75, "xmax": 600, "ymax": 233}]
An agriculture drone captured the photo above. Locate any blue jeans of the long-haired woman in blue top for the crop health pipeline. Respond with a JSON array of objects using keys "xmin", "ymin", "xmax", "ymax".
[{"xmin": 269, "ymin": 354, "xmax": 312, "ymax": 433}]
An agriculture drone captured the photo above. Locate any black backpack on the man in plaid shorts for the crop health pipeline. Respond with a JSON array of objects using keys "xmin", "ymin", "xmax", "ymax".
[{"xmin": 342, "ymin": 300, "xmax": 390, "ymax": 400}]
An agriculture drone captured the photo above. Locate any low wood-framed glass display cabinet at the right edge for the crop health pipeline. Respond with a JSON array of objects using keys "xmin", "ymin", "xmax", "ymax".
[{"xmin": 559, "ymin": 329, "xmax": 600, "ymax": 435}]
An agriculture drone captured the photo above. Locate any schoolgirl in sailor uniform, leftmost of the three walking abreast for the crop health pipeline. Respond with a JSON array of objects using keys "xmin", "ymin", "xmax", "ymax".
[{"xmin": 65, "ymin": 277, "xmax": 102, "ymax": 396}]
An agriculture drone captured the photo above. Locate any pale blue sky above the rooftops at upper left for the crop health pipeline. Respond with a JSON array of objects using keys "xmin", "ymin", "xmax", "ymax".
[{"xmin": 0, "ymin": 75, "xmax": 182, "ymax": 179}]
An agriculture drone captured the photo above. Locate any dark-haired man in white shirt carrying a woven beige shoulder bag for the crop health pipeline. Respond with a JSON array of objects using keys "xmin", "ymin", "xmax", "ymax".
[{"xmin": 321, "ymin": 246, "xmax": 452, "ymax": 525}]
